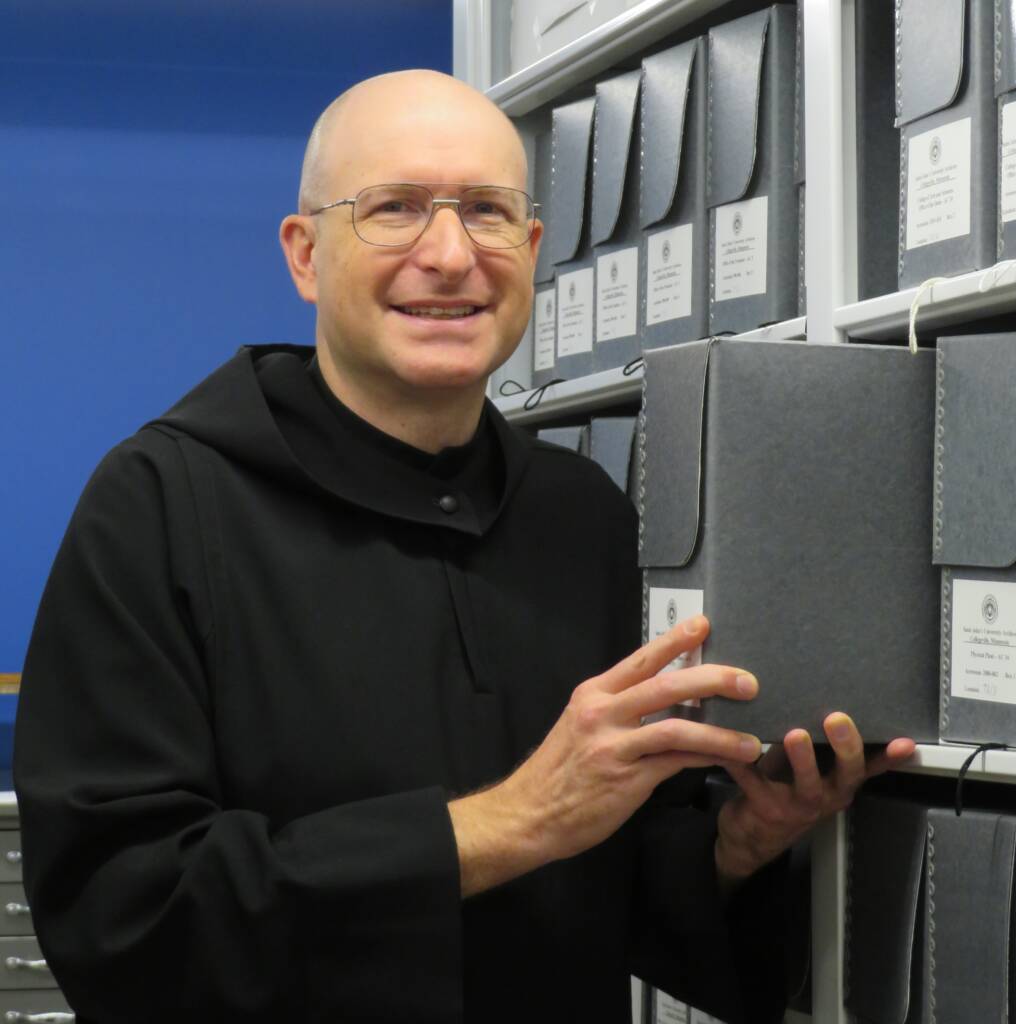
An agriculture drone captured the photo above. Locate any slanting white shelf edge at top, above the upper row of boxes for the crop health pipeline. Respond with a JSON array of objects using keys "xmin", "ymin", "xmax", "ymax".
[{"xmin": 486, "ymin": 0, "xmax": 726, "ymax": 118}]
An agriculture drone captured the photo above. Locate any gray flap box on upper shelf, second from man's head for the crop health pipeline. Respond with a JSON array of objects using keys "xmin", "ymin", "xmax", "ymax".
[{"xmin": 547, "ymin": 96, "xmax": 596, "ymax": 379}]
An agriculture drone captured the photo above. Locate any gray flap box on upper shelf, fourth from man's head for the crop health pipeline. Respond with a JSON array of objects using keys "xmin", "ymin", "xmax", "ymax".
[{"xmin": 639, "ymin": 38, "xmax": 709, "ymax": 348}]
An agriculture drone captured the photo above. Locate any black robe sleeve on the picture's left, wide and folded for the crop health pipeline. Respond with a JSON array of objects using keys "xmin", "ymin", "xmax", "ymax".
[{"xmin": 14, "ymin": 432, "xmax": 462, "ymax": 1024}]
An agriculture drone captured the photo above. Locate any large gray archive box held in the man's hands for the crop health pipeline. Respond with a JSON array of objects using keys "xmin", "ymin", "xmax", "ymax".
[{"xmin": 638, "ymin": 338, "xmax": 938, "ymax": 742}]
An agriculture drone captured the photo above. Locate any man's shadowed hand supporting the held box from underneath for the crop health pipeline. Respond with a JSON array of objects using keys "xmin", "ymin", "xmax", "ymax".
[{"xmin": 716, "ymin": 712, "xmax": 915, "ymax": 888}]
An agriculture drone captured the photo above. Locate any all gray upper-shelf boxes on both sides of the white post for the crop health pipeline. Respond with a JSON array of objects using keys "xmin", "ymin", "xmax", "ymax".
[{"xmin": 513, "ymin": 0, "xmax": 1016, "ymax": 386}]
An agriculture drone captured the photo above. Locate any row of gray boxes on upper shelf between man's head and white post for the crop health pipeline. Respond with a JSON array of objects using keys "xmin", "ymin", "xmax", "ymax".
[{"xmin": 520, "ymin": 4, "xmax": 804, "ymax": 385}]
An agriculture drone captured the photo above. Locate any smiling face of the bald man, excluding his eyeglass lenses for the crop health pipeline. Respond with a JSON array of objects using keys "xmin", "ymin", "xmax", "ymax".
[{"xmin": 283, "ymin": 72, "xmax": 540, "ymax": 421}]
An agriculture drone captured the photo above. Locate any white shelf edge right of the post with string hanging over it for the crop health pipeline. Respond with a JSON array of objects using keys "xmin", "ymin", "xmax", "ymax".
[{"xmin": 833, "ymin": 263, "xmax": 1016, "ymax": 341}]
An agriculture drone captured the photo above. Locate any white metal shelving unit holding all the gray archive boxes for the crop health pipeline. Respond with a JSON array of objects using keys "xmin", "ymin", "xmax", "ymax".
[{"xmin": 455, "ymin": 0, "xmax": 1016, "ymax": 1024}]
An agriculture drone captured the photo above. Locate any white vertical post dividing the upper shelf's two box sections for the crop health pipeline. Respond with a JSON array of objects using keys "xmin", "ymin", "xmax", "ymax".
[{"xmin": 799, "ymin": 0, "xmax": 857, "ymax": 341}]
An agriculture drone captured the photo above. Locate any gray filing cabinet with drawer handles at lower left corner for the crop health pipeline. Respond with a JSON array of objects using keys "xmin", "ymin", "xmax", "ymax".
[{"xmin": 0, "ymin": 793, "xmax": 74, "ymax": 1024}]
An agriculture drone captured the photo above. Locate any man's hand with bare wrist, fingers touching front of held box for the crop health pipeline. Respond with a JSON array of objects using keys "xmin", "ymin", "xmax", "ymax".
[{"xmin": 449, "ymin": 615, "xmax": 761, "ymax": 897}]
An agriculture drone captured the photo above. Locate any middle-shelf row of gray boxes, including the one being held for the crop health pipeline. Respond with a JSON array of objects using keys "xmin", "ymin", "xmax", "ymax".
[{"xmin": 545, "ymin": 335, "xmax": 1016, "ymax": 744}]
